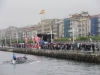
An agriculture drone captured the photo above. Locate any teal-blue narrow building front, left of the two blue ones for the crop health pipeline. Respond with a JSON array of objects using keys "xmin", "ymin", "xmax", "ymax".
[{"xmin": 64, "ymin": 18, "xmax": 70, "ymax": 38}]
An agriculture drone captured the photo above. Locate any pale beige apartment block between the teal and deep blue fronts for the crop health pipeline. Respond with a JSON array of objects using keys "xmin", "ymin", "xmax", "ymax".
[{"xmin": 69, "ymin": 11, "xmax": 90, "ymax": 37}]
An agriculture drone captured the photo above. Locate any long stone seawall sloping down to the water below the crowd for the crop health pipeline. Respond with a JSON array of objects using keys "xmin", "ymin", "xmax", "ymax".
[{"xmin": 0, "ymin": 47, "xmax": 100, "ymax": 63}]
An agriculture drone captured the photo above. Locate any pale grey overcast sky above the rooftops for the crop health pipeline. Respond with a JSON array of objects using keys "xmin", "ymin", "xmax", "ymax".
[{"xmin": 0, "ymin": 0, "xmax": 100, "ymax": 29}]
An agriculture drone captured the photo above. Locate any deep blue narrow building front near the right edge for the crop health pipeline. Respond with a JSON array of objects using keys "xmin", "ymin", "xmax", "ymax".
[{"xmin": 90, "ymin": 17, "xmax": 98, "ymax": 36}]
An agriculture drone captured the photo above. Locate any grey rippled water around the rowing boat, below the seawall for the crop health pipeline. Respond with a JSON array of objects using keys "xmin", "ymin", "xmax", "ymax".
[{"xmin": 0, "ymin": 52, "xmax": 100, "ymax": 75}]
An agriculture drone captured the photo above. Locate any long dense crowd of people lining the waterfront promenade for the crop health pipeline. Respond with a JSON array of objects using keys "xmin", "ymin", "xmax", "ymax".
[{"xmin": 0, "ymin": 41, "xmax": 100, "ymax": 52}]
